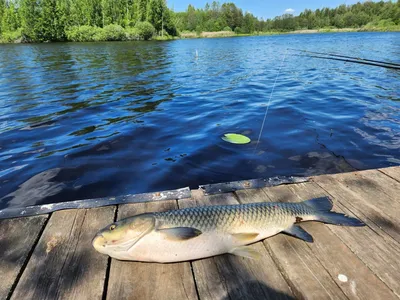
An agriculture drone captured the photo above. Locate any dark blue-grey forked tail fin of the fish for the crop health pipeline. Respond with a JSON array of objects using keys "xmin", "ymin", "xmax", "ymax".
[{"xmin": 303, "ymin": 197, "xmax": 365, "ymax": 226}]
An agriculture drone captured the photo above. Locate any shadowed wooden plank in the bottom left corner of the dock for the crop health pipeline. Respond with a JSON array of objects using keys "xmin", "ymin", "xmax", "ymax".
[{"xmin": 0, "ymin": 215, "xmax": 48, "ymax": 299}]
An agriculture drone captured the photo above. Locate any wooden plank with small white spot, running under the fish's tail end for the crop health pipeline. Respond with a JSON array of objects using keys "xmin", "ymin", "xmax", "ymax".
[{"xmin": 265, "ymin": 186, "xmax": 397, "ymax": 299}]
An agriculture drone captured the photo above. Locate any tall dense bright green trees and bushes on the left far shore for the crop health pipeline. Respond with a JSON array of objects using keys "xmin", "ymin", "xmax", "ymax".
[{"xmin": 0, "ymin": 0, "xmax": 177, "ymax": 42}]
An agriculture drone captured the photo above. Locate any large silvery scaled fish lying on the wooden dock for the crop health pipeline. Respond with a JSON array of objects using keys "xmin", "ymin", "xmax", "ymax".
[{"xmin": 92, "ymin": 197, "xmax": 365, "ymax": 263}]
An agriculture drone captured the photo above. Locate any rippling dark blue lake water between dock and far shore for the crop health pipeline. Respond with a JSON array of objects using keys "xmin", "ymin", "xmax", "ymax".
[{"xmin": 0, "ymin": 33, "xmax": 400, "ymax": 208}]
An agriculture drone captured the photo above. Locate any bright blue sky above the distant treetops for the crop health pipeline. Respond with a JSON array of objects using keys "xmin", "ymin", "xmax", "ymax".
[{"xmin": 167, "ymin": 0, "xmax": 378, "ymax": 19}]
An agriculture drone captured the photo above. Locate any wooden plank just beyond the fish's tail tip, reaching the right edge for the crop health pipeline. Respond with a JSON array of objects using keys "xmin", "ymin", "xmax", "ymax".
[{"xmin": 312, "ymin": 175, "xmax": 400, "ymax": 243}]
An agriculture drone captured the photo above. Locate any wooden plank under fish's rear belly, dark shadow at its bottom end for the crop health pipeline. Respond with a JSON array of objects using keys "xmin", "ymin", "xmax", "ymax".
[{"xmin": 179, "ymin": 191, "xmax": 293, "ymax": 299}]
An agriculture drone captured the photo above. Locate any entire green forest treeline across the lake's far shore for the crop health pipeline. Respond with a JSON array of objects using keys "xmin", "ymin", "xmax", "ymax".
[{"xmin": 0, "ymin": 0, "xmax": 400, "ymax": 42}]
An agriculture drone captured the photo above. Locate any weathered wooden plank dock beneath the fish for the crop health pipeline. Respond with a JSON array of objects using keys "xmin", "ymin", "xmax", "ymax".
[{"xmin": 0, "ymin": 167, "xmax": 400, "ymax": 300}]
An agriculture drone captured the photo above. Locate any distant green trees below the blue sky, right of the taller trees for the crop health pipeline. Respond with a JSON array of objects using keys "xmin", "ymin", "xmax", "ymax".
[{"xmin": 175, "ymin": 0, "xmax": 400, "ymax": 33}]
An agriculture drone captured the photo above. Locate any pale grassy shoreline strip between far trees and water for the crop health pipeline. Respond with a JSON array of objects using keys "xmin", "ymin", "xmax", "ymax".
[{"xmin": 0, "ymin": 26, "xmax": 400, "ymax": 45}]
